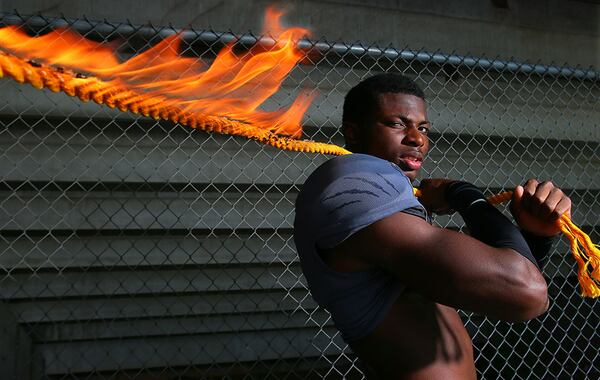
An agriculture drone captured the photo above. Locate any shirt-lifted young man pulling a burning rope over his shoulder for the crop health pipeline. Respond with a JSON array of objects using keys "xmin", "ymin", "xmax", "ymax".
[{"xmin": 294, "ymin": 74, "xmax": 571, "ymax": 380}]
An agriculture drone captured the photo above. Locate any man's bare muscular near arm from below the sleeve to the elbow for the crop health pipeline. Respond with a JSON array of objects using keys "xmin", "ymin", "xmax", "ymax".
[{"xmin": 334, "ymin": 212, "xmax": 548, "ymax": 321}]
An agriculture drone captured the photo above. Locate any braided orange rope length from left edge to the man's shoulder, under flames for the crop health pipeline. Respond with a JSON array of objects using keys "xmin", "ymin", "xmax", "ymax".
[{"xmin": 0, "ymin": 52, "xmax": 350, "ymax": 156}]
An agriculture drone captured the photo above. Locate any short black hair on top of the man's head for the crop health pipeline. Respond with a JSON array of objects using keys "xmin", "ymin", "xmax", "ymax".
[{"xmin": 342, "ymin": 73, "xmax": 425, "ymax": 124}]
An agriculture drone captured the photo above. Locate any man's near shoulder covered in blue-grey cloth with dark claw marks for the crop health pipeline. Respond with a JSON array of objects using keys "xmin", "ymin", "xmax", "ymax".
[{"xmin": 294, "ymin": 155, "xmax": 422, "ymax": 255}]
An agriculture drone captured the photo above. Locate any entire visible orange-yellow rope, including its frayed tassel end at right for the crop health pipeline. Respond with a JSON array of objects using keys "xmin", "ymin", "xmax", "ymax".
[{"xmin": 0, "ymin": 52, "xmax": 600, "ymax": 298}]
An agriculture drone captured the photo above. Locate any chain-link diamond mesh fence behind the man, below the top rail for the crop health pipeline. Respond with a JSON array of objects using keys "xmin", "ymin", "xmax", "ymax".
[{"xmin": 0, "ymin": 14, "xmax": 600, "ymax": 379}]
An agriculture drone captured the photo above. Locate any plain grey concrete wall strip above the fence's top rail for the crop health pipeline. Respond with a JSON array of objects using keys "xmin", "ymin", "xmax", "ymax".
[{"xmin": 0, "ymin": 0, "xmax": 600, "ymax": 68}]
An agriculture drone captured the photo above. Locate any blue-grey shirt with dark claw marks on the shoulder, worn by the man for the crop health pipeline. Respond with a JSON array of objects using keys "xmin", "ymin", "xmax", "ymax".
[{"xmin": 294, "ymin": 154, "xmax": 426, "ymax": 342}]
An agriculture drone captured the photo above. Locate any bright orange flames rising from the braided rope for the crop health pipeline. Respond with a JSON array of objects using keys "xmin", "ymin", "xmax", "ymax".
[{"xmin": 0, "ymin": 8, "xmax": 314, "ymax": 138}]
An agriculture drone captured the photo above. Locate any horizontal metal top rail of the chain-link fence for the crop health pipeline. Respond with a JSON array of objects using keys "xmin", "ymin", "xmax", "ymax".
[{"xmin": 0, "ymin": 12, "xmax": 600, "ymax": 81}]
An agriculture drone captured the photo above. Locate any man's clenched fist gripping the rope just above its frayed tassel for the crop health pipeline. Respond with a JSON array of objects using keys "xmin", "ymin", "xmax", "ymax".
[{"xmin": 510, "ymin": 179, "xmax": 571, "ymax": 236}]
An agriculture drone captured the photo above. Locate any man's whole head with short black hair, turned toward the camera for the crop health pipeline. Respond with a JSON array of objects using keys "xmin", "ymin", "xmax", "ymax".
[{"xmin": 342, "ymin": 74, "xmax": 430, "ymax": 180}]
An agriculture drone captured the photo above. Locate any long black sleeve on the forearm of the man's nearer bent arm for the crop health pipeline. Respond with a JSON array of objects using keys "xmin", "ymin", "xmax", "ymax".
[{"xmin": 446, "ymin": 182, "xmax": 540, "ymax": 268}]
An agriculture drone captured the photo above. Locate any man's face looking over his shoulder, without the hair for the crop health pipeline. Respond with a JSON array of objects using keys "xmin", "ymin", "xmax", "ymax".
[{"xmin": 363, "ymin": 93, "xmax": 430, "ymax": 181}]
